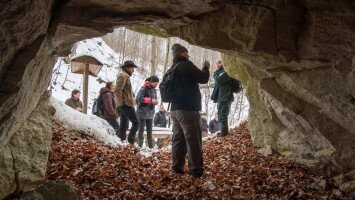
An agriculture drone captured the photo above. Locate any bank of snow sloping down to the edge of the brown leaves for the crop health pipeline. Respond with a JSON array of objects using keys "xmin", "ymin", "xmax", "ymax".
[{"xmin": 51, "ymin": 97, "xmax": 123, "ymax": 147}]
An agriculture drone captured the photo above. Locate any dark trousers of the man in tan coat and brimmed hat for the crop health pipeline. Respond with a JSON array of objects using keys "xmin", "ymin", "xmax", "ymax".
[{"xmin": 119, "ymin": 105, "xmax": 139, "ymax": 144}]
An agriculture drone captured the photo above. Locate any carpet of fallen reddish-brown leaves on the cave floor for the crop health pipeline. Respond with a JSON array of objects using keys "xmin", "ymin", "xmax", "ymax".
[{"xmin": 41, "ymin": 122, "xmax": 350, "ymax": 199}]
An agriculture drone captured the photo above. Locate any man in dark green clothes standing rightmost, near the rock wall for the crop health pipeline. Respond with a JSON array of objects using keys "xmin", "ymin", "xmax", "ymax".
[{"xmin": 211, "ymin": 61, "xmax": 234, "ymax": 136}]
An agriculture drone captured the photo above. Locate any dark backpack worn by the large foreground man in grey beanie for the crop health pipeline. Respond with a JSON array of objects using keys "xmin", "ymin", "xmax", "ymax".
[{"xmin": 159, "ymin": 63, "xmax": 180, "ymax": 103}]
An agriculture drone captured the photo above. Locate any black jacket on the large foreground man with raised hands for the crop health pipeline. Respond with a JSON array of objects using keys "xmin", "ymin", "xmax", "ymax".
[{"xmin": 171, "ymin": 56, "xmax": 210, "ymax": 111}]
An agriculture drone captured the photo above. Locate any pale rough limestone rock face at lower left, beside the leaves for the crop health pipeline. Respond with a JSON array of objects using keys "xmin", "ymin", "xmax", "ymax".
[{"xmin": 0, "ymin": 93, "xmax": 55, "ymax": 199}]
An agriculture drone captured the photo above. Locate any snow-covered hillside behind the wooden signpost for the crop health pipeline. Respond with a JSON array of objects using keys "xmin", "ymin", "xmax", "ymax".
[{"xmin": 50, "ymin": 38, "xmax": 146, "ymax": 113}]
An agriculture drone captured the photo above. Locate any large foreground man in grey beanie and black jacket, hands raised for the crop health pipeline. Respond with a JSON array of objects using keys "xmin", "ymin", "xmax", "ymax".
[{"xmin": 171, "ymin": 44, "xmax": 210, "ymax": 178}]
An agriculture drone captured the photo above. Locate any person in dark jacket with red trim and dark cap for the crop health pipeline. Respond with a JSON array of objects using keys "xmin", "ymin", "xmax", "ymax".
[{"xmin": 136, "ymin": 76, "xmax": 159, "ymax": 148}]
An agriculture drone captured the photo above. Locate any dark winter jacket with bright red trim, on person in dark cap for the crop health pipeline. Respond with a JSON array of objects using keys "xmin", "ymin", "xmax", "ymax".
[{"xmin": 136, "ymin": 81, "xmax": 157, "ymax": 119}]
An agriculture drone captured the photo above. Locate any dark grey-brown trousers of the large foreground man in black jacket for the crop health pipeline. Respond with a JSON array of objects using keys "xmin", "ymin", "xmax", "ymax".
[{"xmin": 171, "ymin": 110, "xmax": 204, "ymax": 176}]
